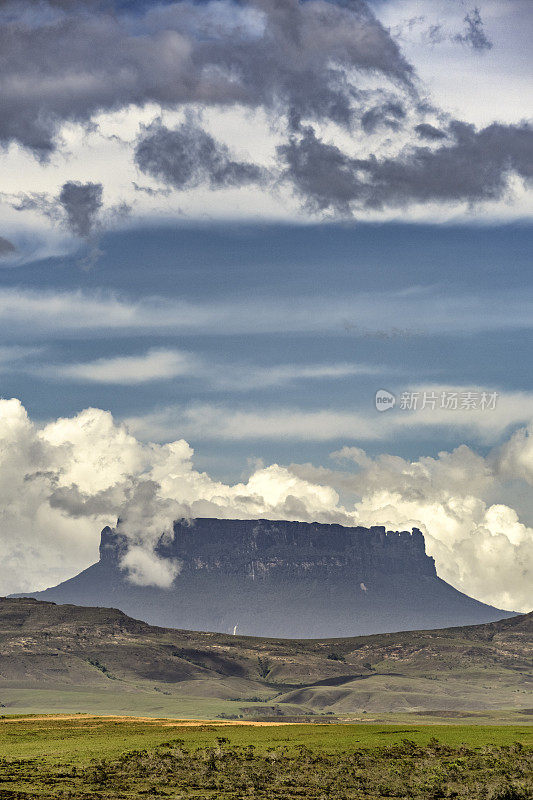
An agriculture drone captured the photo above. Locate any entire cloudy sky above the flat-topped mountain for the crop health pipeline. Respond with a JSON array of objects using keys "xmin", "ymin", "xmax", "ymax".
[{"xmin": 0, "ymin": 0, "xmax": 533, "ymax": 611}]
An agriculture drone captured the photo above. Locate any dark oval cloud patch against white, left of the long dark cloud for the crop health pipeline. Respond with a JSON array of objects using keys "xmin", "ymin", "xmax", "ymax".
[{"xmin": 135, "ymin": 122, "xmax": 263, "ymax": 189}]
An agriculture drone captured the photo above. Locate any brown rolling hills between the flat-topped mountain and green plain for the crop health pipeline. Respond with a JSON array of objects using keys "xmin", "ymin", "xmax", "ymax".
[{"xmin": 0, "ymin": 599, "xmax": 533, "ymax": 716}]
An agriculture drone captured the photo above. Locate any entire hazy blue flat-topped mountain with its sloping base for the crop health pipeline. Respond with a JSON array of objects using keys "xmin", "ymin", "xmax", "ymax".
[{"xmin": 18, "ymin": 519, "xmax": 511, "ymax": 638}]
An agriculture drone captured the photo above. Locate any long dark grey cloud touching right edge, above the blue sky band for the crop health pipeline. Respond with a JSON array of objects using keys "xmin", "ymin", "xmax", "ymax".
[{"xmin": 278, "ymin": 121, "xmax": 533, "ymax": 212}]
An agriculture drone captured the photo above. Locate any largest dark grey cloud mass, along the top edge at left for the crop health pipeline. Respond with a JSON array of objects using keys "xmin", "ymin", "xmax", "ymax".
[{"xmin": 0, "ymin": 0, "xmax": 412, "ymax": 158}]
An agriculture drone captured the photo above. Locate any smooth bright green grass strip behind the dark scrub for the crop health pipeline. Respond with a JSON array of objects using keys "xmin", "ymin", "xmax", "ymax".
[{"xmin": 0, "ymin": 714, "xmax": 533, "ymax": 765}]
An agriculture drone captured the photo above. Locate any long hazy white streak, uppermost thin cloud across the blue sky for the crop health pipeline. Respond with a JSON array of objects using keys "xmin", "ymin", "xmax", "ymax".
[{"xmin": 0, "ymin": 286, "xmax": 533, "ymax": 342}]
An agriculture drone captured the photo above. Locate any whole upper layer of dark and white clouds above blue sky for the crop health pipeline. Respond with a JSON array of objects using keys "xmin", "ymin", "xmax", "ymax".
[{"xmin": 0, "ymin": 0, "xmax": 533, "ymax": 252}]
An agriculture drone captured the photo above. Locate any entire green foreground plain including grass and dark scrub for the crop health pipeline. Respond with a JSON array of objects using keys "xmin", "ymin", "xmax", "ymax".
[{"xmin": 0, "ymin": 716, "xmax": 533, "ymax": 800}]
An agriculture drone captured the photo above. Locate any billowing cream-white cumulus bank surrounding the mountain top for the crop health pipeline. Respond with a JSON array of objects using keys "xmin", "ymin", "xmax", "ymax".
[{"xmin": 0, "ymin": 400, "xmax": 533, "ymax": 610}]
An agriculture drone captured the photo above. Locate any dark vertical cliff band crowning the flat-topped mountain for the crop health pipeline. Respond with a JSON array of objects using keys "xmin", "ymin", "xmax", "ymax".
[{"xmin": 100, "ymin": 519, "xmax": 436, "ymax": 580}]
